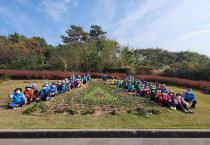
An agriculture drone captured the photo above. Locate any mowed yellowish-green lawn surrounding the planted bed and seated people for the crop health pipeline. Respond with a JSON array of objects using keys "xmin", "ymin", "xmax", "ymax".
[{"xmin": 0, "ymin": 80, "xmax": 210, "ymax": 129}]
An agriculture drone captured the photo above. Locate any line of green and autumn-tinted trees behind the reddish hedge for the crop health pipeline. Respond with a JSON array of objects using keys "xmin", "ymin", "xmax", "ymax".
[{"xmin": 0, "ymin": 25, "xmax": 210, "ymax": 81}]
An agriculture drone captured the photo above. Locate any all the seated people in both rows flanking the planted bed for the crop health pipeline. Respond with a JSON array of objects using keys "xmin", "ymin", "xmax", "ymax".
[{"xmin": 8, "ymin": 75, "xmax": 197, "ymax": 113}]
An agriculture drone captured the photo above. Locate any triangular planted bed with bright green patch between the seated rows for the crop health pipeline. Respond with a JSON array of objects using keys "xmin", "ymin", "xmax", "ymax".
[{"xmin": 23, "ymin": 81, "xmax": 160, "ymax": 117}]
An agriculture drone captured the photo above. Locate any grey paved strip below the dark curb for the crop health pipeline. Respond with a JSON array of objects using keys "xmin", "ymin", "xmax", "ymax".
[{"xmin": 0, "ymin": 138, "xmax": 210, "ymax": 145}]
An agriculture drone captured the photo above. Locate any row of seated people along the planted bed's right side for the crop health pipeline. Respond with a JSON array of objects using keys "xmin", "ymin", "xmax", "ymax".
[{"xmin": 106, "ymin": 75, "xmax": 197, "ymax": 113}]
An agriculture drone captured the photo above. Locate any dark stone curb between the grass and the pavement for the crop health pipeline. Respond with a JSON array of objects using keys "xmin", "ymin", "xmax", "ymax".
[{"xmin": 0, "ymin": 129, "xmax": 210, "ymax": 139}]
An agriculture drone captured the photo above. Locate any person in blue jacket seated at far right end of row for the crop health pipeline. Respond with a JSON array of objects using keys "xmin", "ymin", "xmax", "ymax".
[{"xmin": 183, "ymin": 88, "xmax": 197, "ymax": 108}]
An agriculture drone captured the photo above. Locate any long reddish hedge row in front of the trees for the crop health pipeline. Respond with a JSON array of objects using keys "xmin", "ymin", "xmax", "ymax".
[{"xmin": 0, "ymin": 70, "xmax": 210, "ymax": 93}]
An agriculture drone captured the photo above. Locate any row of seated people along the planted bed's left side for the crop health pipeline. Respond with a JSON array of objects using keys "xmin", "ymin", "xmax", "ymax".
[{"xmin": 8, "ymin": 75, "xmax": 91, "ymax": 109}]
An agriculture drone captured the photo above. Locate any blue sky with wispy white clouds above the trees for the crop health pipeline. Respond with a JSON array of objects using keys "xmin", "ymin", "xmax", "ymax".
[{"xmin": 0, "ymin": 0, "xmax": 210, "ymax": 56}]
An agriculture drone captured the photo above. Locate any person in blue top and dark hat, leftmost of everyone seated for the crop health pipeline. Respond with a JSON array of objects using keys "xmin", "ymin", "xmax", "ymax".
[{"xmin": 8, "ymin": 88, "xmax": 27, "ymax": 109}]
